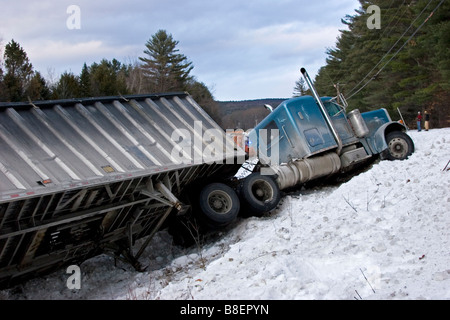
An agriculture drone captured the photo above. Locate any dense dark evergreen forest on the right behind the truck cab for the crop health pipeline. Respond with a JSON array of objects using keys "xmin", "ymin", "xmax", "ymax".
[{"xmin": 312, "ymin": 0, "xmax": 450, "ymax": 128}]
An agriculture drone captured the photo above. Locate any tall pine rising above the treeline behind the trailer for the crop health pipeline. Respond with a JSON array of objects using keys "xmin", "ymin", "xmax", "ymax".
[{"xmin": 139, "ymin": 30, "xmax": 193, "ymax": 92}]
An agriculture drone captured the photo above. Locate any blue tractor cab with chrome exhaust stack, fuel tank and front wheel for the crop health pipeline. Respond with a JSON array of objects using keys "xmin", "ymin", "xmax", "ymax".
[{"xmin": 244, "ymin": 69, "xmax": 414, "ymax": 189}]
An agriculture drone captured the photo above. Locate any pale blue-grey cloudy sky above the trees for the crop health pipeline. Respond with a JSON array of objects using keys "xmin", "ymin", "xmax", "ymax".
[{"xmin": 0, "ymin": 0, "xmax": 359, "ymax": 101}]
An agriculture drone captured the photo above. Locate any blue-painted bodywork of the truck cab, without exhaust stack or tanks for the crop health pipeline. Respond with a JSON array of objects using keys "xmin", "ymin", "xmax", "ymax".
[{"xmin": 249, "ymin": 96, "xmax": 406, "ymax": 163}]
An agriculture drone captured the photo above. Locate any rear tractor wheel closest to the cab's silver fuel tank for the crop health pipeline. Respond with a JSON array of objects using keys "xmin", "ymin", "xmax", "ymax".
[{"xmin": 241, "ymin": 172, "xmax": 281, "ymax": 216}]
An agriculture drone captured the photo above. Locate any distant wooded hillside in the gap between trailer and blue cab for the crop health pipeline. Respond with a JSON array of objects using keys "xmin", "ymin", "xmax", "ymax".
[{"xmin": 216, "ymin": 99, "xmax": 286, "ymax": 130}]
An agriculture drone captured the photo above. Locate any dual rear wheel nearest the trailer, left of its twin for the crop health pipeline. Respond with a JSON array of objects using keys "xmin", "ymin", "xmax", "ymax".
[{"xmin": 199, "ymin": 183, "xmax": 240, "ymax": 228}]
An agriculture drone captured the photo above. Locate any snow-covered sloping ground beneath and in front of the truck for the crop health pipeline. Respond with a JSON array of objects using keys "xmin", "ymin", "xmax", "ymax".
[{"xmin": 0, "ymin": 128, "xmax": 450, "ymax": 300}]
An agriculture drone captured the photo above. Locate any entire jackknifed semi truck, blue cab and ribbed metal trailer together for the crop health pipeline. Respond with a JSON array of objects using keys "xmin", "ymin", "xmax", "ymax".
[{"xmin": 0, "ymin": 69, "xmax": 414, "ymax": 287}]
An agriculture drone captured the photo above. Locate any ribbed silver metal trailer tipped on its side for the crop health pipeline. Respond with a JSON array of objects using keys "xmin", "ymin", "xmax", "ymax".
[{"xmin": 0, "ymin": 93, "xmax": 243, "ymax": 287}]
